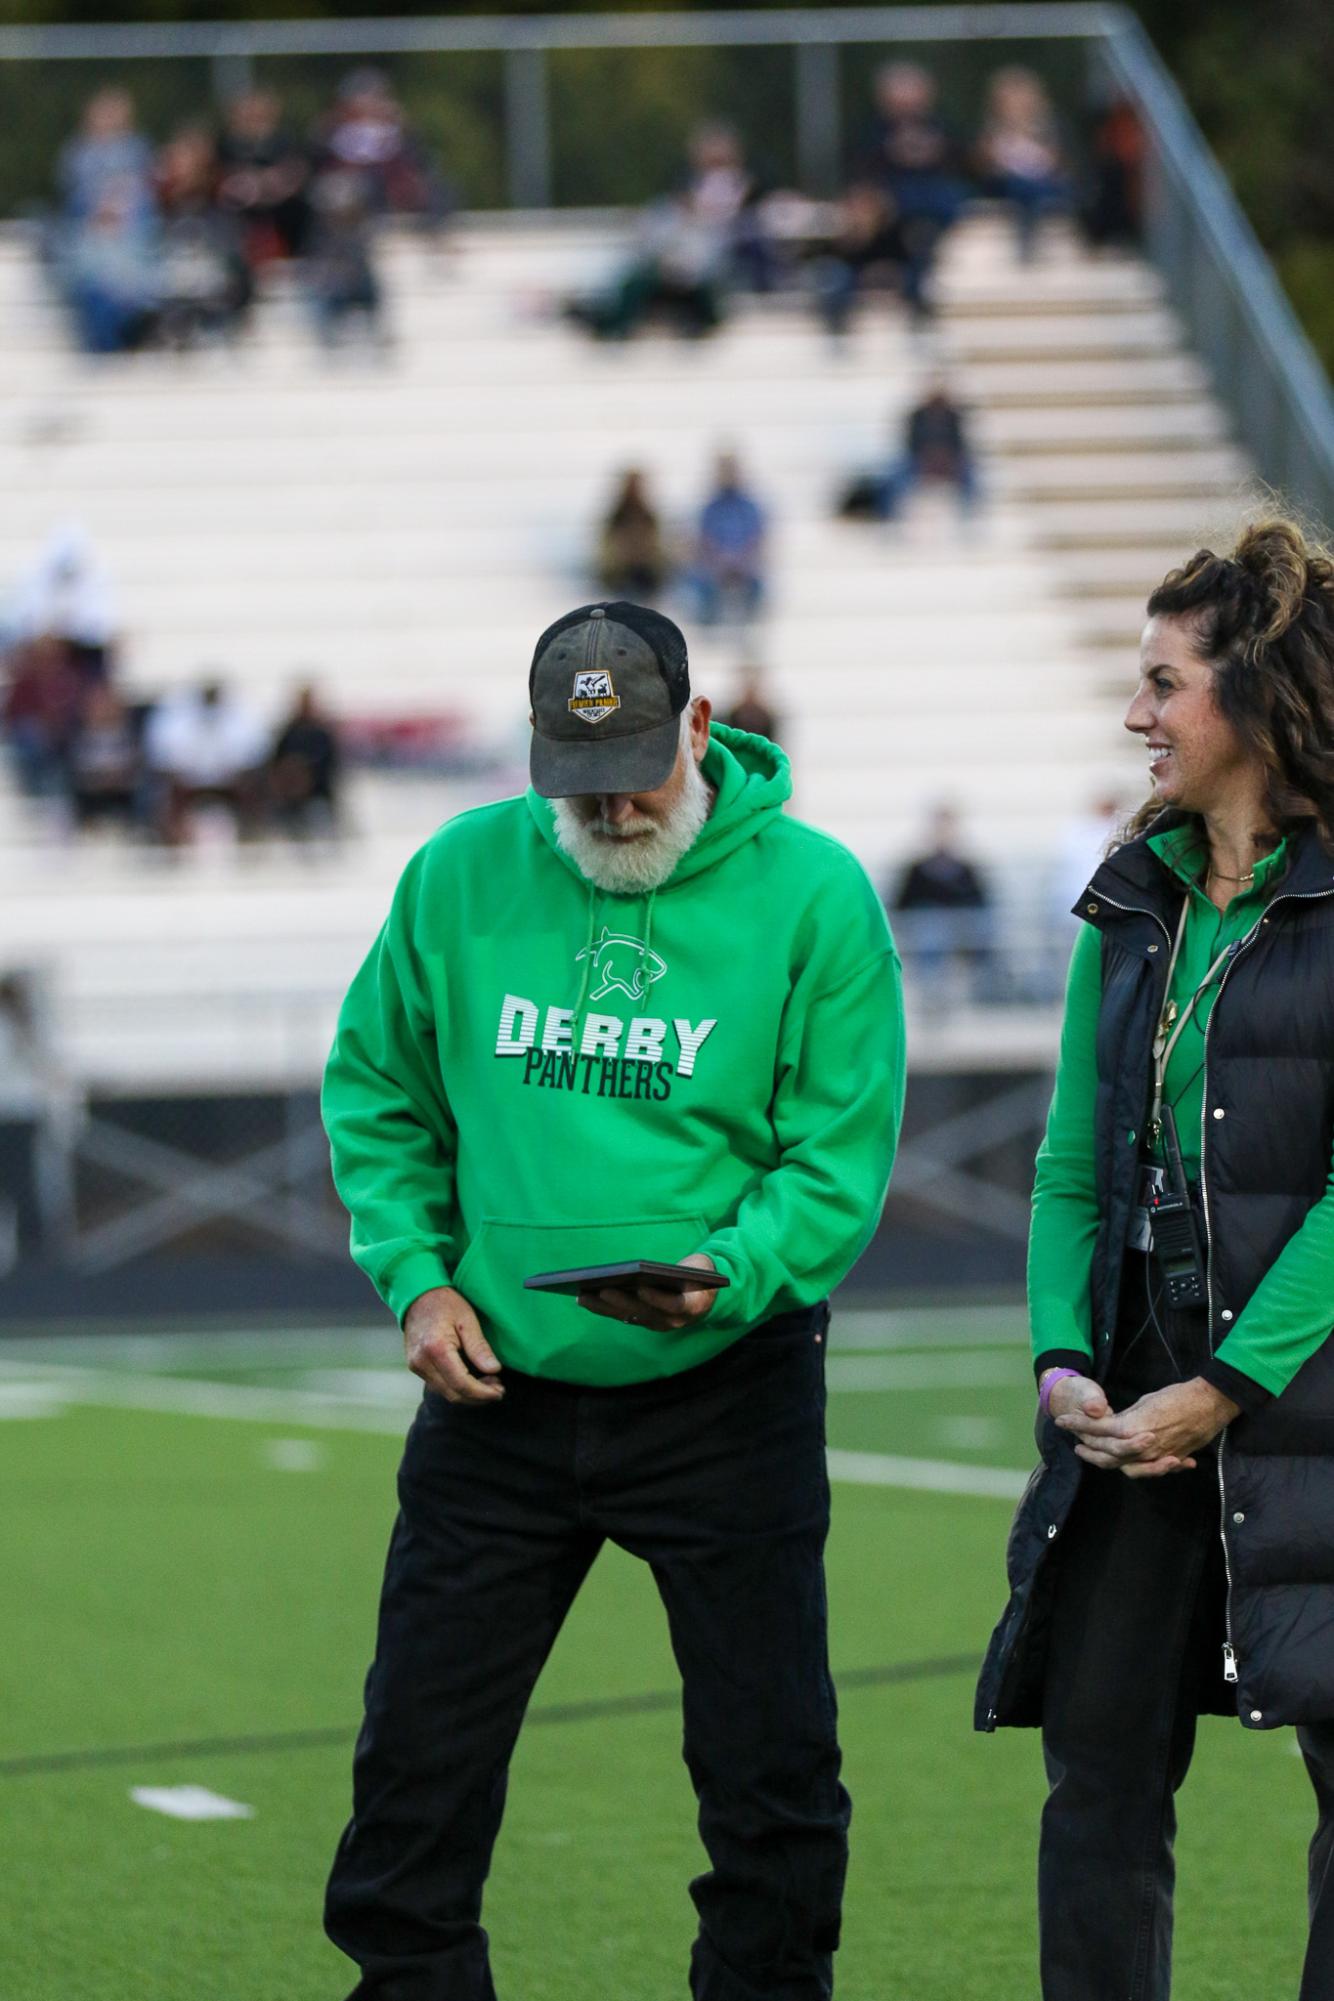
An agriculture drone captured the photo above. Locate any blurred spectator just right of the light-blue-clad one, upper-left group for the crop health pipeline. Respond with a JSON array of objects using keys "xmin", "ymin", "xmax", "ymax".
[{"xmin": 156, "ymin": 126, "xmax": 254, "ymax": 348}]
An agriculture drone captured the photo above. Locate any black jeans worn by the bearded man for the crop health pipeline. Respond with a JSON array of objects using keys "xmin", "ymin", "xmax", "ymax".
[{"xmin": 326, "ymin": 1307, "xmax": 850, "ymax": 2001}]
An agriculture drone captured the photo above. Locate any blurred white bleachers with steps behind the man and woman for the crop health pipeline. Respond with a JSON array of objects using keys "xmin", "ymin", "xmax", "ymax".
[{"xmin": 0, "ymin": 216, "xmax": 1246, "ymax": 1091}]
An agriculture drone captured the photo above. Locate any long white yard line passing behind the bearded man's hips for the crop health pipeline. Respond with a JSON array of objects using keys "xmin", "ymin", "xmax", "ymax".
[{"xmin": 0, "ymin": 1363, "xmax": 1026, "ymax": 1501}]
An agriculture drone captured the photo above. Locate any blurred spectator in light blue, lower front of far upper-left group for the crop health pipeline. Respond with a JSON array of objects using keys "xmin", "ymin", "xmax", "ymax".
[{"xmin": 56, "ymin": 182, "xmax": 162, "ymax": 354}]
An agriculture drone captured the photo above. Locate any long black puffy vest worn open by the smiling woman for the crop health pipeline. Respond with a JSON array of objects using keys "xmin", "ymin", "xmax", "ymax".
[{"xmin": 976, "ymin": 814, "xmax": 1334, "ymax": 1729}]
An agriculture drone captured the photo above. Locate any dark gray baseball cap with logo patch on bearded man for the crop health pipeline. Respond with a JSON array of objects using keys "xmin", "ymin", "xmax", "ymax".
[{"xmin": 528, "ymin": 598, "xmax": 690, "ymax": 798}]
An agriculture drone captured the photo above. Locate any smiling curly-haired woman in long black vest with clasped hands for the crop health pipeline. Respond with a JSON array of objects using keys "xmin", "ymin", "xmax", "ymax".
[{"xmin": 978, "ymin": 520, "xmax": 1334, "ymax": 2001}]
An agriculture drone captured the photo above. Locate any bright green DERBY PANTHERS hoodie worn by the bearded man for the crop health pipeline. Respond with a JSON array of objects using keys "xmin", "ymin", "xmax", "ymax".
[{"xmin": 324, "ymin": 728, "xmax": 904, "ymax": 1383}]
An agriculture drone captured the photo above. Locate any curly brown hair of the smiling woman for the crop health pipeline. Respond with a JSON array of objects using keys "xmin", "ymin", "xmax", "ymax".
[{"xmin": 1126, "ymin": 516, "xmax": 1334, "ymax": 848}]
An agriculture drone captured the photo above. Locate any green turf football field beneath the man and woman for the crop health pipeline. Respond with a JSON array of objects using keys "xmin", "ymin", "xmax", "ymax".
[{"xmin": 0, "ymin": 1309, "xmax": 1310, "ymax": 2001}]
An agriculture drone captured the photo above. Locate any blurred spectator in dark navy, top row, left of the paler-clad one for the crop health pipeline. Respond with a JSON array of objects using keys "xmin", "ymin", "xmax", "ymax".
[{"xmin": 862, "ymin": 62, "xmax": 968, "ymax": 314}]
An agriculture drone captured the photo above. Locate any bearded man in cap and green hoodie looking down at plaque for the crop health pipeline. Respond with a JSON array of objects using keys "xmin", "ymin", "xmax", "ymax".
[{"xmin": 324, "ymin": 602, "xmax": 904, "ymax": 2001}]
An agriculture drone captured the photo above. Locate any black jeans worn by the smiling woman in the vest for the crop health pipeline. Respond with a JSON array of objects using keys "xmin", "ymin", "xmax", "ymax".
[{"xmin": 1038, "ymin": 1253, "xmax": 1334, "ymax": 2001}]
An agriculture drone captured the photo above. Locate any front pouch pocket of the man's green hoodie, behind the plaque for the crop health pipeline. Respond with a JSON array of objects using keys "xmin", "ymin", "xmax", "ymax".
[{"xmin": 454, "ymin": 1215, "xmax": 730, "ymax": 1383}]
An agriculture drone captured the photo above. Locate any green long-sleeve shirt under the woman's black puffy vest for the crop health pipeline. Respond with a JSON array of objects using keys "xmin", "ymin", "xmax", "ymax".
[{"xmin": 1028, "ymin": 826, "xmax": 1334, "ymax": 1407}]
